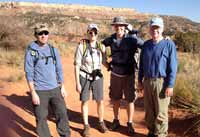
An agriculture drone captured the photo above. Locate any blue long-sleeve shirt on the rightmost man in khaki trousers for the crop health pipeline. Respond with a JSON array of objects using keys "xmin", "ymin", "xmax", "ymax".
[{"xmin": 138, "ymin": 39, "xmax": 177, "ymax": 87}]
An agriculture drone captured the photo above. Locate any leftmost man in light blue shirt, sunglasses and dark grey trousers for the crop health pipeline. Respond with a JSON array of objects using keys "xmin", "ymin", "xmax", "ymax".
[{"xmin": 24, "ymin": 24, "xmax": 70, "ymax": 137}]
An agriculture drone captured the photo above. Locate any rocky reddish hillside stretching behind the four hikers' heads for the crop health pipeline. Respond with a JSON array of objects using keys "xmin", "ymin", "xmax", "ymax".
[{"xmin": 0, "ymin": 2, "xmax": 200, "ymax": 47}]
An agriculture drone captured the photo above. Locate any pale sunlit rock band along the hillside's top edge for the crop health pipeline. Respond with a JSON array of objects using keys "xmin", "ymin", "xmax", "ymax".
[{"xmin": 0, "ymin": 2, "xmax": 146, "ymax": 19}]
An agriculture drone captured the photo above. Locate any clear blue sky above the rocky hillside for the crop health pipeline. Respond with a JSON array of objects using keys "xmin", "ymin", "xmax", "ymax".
[{"xmin": 0, "ymin": 0, "xmax": 200, "ymax": 23}]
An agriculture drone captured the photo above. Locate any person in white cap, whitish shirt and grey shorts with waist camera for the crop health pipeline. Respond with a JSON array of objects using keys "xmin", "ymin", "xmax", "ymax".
[{"xmin": 74, "ymin": 24, "xmax": 108, "ymax": 137}]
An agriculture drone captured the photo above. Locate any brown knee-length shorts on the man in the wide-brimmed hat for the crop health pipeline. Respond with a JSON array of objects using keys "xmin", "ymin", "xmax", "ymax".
[{"xmin": 109, "ymin": 73, "xmax": 136, "ymax": 102}]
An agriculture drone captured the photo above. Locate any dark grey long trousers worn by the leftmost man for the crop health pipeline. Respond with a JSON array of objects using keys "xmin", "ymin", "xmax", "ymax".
[{"xmin": 34, "ymin": 87, "xmax": 70, "ymax": 137}]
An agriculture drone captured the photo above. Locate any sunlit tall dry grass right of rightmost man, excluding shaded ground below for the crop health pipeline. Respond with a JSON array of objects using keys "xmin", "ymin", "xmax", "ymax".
[{"xmin": 175, "ymin": 53, "xmax": 200, "ymax": 104}]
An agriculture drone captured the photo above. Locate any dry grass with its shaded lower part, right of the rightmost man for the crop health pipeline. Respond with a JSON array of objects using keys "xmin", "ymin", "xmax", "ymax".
[{"xmin": 172, "ymin": 53, "xmax": 200, "ymax": 137}]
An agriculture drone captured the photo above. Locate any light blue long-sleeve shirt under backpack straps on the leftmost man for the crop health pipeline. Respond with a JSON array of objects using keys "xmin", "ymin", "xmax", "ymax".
[{"xmin": 24, "ymin": 42, "xmax": 64, "ymax": 90}]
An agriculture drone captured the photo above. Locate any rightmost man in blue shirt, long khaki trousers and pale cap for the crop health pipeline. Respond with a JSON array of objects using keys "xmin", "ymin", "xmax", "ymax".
[{"xmin": 138, "ymin": 17, "xmax": 177, "ymax": 137}]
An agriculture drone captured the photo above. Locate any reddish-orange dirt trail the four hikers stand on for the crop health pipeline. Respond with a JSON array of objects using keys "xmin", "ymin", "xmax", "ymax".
[{"xmin": 0, "ymin": 56, "xmax": 191, "ymax": 137}]
